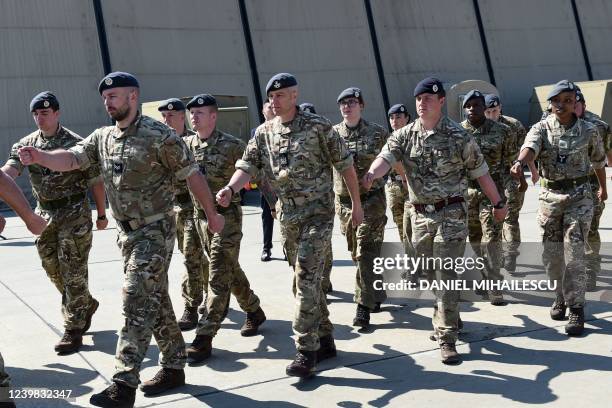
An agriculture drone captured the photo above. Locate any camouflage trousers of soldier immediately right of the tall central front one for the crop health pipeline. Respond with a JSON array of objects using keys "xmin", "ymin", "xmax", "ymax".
[{"xmin": 336, "ymin": 188, "xmax": 387, "ymax": 310}]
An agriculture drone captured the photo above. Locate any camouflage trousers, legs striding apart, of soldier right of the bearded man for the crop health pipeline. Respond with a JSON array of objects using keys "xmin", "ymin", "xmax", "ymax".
[{"xmin": 196, "ymin": 203, "xmax": 259, "ymax": 336}]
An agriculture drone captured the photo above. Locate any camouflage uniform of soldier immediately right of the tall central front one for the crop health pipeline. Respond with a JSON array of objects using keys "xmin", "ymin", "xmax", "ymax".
[{"xmin": 334, "ymin": 119, "xmax": 389, "ymax": 310}]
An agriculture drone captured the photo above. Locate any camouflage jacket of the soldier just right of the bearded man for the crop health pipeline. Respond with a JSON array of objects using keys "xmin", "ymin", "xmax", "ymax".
[{"xmin": 185, "ymin": 129, "xmax": 246, "ymax": 210}]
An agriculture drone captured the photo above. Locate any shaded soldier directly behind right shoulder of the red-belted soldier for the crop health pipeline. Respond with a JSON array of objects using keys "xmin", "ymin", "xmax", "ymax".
[{"xmin": 461, "ymin": 89, "xmax": 516, "ymax": 306}]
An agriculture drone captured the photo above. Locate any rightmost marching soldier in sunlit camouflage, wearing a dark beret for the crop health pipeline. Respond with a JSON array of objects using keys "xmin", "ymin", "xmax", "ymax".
[{"xmin": 511, "ymin": 80, "xmax": 608, "ymax": 336}]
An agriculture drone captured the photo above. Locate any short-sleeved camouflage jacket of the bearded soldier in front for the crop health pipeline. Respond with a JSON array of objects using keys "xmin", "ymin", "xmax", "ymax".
[{"xmin": 70, "ymin": 114, "xmax": 198, "ymax": 221}]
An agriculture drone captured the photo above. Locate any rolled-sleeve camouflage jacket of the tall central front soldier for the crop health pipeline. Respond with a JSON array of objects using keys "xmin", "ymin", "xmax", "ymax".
[{"xmin": 236, "ymin": 111, "xmax": 353, "ymax": 222}]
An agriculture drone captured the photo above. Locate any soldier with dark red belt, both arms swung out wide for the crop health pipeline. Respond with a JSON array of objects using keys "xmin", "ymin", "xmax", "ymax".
[{"xmin": 362, "ymin": 78, "xmax": 507, "ymax": 364}]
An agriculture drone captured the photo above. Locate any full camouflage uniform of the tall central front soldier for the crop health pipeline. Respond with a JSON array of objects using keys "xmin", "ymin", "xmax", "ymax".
[{"xmin": 236, "ymin": 111, "xmax": 353, "ymax": 351}]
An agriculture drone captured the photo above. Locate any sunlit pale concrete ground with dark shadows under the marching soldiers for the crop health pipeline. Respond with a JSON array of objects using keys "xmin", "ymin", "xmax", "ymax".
[{"xmin": 0, "ymin": 171, "xmax": 612, "ymax": 408}]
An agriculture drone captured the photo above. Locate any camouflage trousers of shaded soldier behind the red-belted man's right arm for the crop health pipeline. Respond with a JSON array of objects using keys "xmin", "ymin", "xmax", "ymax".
[{"xmin": 468, "ymin": 188, "xmax": 503, "ymax": 281}]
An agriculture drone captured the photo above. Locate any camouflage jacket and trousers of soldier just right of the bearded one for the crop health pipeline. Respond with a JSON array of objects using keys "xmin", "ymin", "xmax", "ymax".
[{"xmin": 185, "ymin": 130, "xmax": 259, "ymax": 337}]
